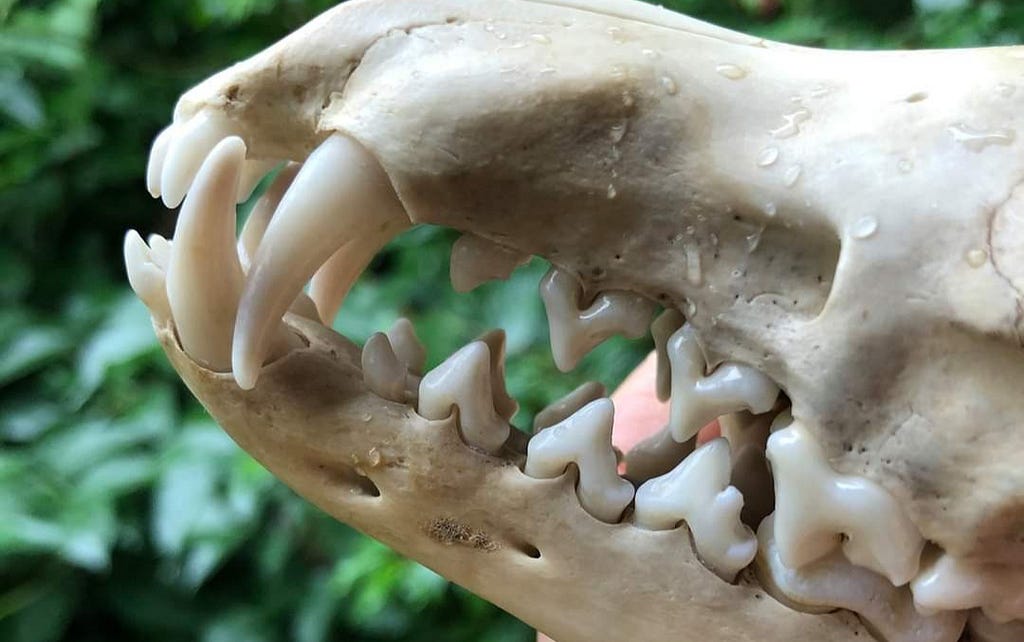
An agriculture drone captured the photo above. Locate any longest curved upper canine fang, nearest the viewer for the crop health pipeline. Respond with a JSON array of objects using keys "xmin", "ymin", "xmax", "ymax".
[{"xmin": 232, "ymin": 134, "xmax": 410, "ymax": 389}]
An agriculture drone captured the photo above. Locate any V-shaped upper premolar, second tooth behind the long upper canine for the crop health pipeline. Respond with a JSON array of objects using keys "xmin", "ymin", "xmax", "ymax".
[{"xmin": 541, "ymin": 267, "xmax": 654, "ymax": 373}]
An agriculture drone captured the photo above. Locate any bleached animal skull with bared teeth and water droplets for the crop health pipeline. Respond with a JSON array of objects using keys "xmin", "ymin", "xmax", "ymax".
[{"xmin": 126, "ymin": 0, "xmax": 1024, "ymax": 642}]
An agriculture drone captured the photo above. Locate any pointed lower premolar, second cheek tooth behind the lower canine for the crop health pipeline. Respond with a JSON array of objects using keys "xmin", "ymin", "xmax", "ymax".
[{"xmin": 417, "ymin": 341, "xmax": 511, "ymax": 454}]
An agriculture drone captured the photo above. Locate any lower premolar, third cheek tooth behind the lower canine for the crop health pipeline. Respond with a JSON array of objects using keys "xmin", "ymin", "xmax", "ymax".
[{"xmin": 524, "ymin": 398, "xmax": 633, "ymax": 523}]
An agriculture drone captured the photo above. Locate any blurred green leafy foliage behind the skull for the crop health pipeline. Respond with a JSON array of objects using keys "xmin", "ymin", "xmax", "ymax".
[{"xmin": 0, "ymin": 0, "xmax": 1024, "ymax": 642}]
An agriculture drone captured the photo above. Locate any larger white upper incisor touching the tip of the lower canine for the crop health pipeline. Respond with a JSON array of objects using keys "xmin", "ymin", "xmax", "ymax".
[{"xmin": 160, "ymin": 112, "xmax": 238, "ymax": 208}]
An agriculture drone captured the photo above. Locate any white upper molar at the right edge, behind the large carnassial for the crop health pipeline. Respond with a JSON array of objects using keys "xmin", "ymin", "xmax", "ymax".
[{"xmin": 910, "ymin": 553, "xmax": 1024, "ymax": 623}]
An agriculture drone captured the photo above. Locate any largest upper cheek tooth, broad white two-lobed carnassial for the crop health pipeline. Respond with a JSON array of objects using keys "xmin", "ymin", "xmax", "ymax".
[{"xmin": 767, "ymin": 421, "xmax": 925, "ymax": 586}]
